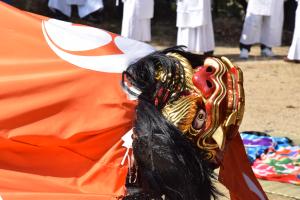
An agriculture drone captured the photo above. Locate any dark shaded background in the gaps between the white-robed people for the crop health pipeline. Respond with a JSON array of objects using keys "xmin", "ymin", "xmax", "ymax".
[{"xmin": 11, "ymin": 0, "xmax": 297, "ymax": 46}]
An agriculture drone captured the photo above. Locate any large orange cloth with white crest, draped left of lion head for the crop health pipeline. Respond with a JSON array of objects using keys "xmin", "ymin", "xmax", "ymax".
[{"xmin": 0, "ymin": 2, "xmax": 153, "ymax": 200}]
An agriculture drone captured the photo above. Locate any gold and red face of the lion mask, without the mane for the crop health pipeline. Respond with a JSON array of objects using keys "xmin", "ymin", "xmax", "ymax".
[{"xmin": 156, "ymin": 53, "xmax": 245, "ymax": 161}]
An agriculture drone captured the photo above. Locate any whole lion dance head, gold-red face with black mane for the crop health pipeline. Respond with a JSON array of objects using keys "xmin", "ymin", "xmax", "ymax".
[{"xmin": 122, "ymin": 47, "xmax": 245, "ymax": 200}]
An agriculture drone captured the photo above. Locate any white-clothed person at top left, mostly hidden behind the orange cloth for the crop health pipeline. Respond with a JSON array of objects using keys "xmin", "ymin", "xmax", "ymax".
[{"xmin": 48, "ymin": 0, "xmax": 104, "ymax": 18}]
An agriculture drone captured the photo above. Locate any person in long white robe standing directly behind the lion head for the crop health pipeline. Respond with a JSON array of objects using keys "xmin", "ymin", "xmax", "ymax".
[{"xmin": 176, "ymin": 0, "xmax": 215, "ymax": 55}]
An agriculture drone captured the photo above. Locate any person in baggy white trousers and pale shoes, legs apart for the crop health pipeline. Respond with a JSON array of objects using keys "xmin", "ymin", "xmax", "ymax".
[{"xmin": 240, "ymin": 0, "xmax": 284, "ymax": 59}]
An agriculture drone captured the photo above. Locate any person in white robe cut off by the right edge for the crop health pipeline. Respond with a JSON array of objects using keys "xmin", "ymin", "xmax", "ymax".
[{"xmin": 286, "ymin": 0, "xmax": 300, "ymax": 63}]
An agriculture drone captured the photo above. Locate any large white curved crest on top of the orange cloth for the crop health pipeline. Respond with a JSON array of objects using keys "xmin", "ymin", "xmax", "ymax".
[{"xmin": 42, "ymin": 19, "xmax": 154, "ymax": 73}]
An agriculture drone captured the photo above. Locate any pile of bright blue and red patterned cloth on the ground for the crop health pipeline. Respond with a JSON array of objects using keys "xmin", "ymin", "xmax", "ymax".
[{"xmin": 241, "ymin": 132, "xmax": 300, "ymax": 185}]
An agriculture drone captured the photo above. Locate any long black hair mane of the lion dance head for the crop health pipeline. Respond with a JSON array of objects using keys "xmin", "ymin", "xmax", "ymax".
[{"xmin": 123, "ymin": 47, "xmax": 218, "ymax": 200}]
